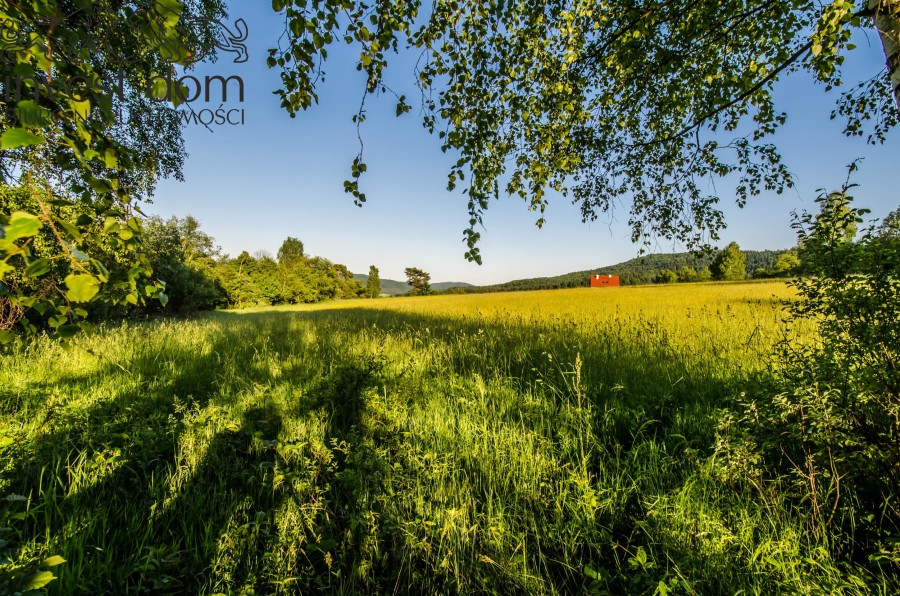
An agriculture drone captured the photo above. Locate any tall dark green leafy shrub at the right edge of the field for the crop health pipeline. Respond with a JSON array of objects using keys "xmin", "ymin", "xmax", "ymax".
[{"xmin": 721, "ymin": 183, "xmax": 900, "ymax": 578}]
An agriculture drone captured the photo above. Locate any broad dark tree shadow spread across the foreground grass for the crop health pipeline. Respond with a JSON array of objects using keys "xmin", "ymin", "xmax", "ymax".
[{"xmin": 0, "ymin": 308, "xmax": 776, "ymax": 593}]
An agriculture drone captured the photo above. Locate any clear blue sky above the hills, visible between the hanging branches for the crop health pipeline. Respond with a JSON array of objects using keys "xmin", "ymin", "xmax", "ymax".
[{"xmin": 145, "ymin": 1, "xmax": 900, "ymax": 284}]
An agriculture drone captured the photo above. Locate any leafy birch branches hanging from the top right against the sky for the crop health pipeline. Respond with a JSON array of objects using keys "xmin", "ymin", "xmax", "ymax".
[{"xmin": 269, "ymin": 0, "xmax": 900, "ymax": 262}]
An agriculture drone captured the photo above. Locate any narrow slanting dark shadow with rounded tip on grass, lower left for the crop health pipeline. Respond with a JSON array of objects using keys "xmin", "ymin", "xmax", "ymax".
[{"xmin": 128, "ymin": 405, "xmax": 282, "ymax": 594}]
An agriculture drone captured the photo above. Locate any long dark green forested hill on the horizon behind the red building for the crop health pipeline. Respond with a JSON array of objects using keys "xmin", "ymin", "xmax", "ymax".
[{"xmin": 458, "ymin": 250, "xmax": 784, "ymax": 293}]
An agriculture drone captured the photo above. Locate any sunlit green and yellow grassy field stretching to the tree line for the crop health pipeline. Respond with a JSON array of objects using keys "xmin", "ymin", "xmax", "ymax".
[{"xmin": 0, "ymin": 282, "xmax": 848, "ymax": 594}]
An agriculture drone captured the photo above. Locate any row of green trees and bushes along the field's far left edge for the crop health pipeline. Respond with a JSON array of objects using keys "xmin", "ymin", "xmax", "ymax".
[{"xmin": 0, "ymin": 201, "xmax": 363, "ymax": 316}]
